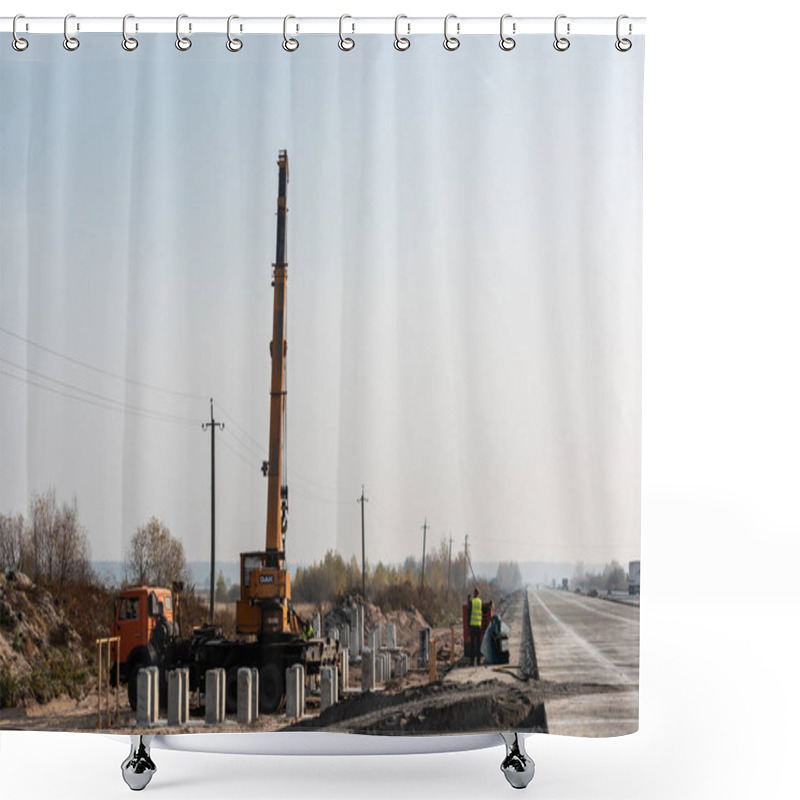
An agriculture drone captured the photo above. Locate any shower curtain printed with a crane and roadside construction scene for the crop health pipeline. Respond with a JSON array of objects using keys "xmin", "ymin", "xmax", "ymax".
[{"xmin": 0, "ymin": 22, "xmax": 644, "ymax": 736}]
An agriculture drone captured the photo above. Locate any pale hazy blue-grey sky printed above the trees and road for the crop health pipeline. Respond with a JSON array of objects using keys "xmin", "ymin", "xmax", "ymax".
[{"xmin": 0, "ymin": 34, "xmax": 643, "ymax": 563}]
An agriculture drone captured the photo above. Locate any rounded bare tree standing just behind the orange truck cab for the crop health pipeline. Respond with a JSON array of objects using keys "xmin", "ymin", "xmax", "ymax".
[{"xmin": 125, "ymin": 517, "xmax": 189, "ymax": 586}]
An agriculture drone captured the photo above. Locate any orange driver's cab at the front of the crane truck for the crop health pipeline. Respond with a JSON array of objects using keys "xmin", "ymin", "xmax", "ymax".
[{"xmin": 111, "ymin": 586, "xmax": 173, "ymax": 682}]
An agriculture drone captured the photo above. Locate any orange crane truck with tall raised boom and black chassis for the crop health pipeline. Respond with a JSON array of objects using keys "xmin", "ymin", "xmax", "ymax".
[{"xmin": 111, "ymin": 150, "xmax": 340, "ymax": 713}]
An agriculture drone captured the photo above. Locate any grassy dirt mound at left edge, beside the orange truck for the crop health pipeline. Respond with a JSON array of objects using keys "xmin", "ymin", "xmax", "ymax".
[{"xmin": 0, "ymin": 572, "xmax": 89, "ymax": 709}]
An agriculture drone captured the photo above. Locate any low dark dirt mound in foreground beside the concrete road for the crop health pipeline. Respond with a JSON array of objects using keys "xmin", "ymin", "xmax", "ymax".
[{"xmin": 290, "ymin": 681, "xmax": 547, "ymax": 735}]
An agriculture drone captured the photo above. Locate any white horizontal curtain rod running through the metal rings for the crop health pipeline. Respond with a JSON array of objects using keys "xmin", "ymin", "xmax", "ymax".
[{"xmin": 0, "ymin": 15, "xmax": 646, "ymax": 36}]
